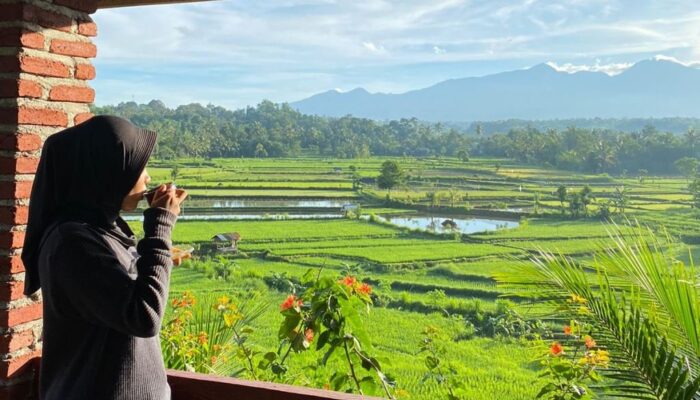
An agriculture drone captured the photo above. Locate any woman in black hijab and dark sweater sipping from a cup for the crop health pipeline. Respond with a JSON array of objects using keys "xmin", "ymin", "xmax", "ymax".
[{"xmin": 22, "ymin": 116, "xmax": 187, "ymax": 400}]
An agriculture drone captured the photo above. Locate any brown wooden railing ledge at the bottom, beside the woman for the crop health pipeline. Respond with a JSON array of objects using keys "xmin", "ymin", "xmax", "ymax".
[{"xmin": 168, "ymin": 370, "xmax": 378, "ymax": 400}]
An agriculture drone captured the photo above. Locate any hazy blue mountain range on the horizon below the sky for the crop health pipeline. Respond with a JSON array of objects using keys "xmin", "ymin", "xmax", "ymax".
[{"xmin": 290, "ymin": 59, "xmax": 700, "ymax": 122}]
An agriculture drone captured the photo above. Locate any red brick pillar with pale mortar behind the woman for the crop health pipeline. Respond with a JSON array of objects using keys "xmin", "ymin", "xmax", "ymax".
[{"xmin": 0, "ymin": 0, "xmax": 97, "ymax": 400}]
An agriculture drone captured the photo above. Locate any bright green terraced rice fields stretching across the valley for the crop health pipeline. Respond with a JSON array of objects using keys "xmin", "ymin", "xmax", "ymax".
[{"xmin": 130, "ymin": 158, "xmax": 700, "ymax": 400}]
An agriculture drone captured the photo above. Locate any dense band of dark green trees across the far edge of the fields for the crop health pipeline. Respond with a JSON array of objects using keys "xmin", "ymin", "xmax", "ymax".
[{"xmin": 92, "ymin": 100, "xmax": 700, "ymax": 176}]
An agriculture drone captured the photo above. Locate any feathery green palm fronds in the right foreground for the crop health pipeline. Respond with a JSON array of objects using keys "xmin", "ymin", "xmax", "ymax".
[{"xmin": 497, "ymin": 226, "xmax": 700, "ymax": 400}]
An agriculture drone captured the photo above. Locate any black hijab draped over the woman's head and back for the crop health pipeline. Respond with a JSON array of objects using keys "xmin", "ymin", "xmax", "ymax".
[{"xmin": 22, "ymin": 116, "xmax": 156, "ymax": 296}]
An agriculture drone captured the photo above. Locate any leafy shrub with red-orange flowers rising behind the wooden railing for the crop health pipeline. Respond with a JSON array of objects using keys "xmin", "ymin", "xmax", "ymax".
[{"xmin": 261, "ymin": 274, "xmax": 394, "ymax": 398}]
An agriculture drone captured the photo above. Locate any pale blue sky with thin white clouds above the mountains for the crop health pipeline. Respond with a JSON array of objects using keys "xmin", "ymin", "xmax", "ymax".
[{"xmin": 92, "ymin": 0, "xmax": 700, "ymax": 109}]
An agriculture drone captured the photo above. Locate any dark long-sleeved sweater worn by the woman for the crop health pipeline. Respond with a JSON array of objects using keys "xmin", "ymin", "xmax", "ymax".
[{"xmin": 38, "ymin": 208, "xmax": 177, "ymax": 400}]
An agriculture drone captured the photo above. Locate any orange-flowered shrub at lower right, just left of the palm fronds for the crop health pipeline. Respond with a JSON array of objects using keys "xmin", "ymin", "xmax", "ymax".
[{"xmin": 537, "ymin": 318, "xmax": 610, "ymax": 400}]
